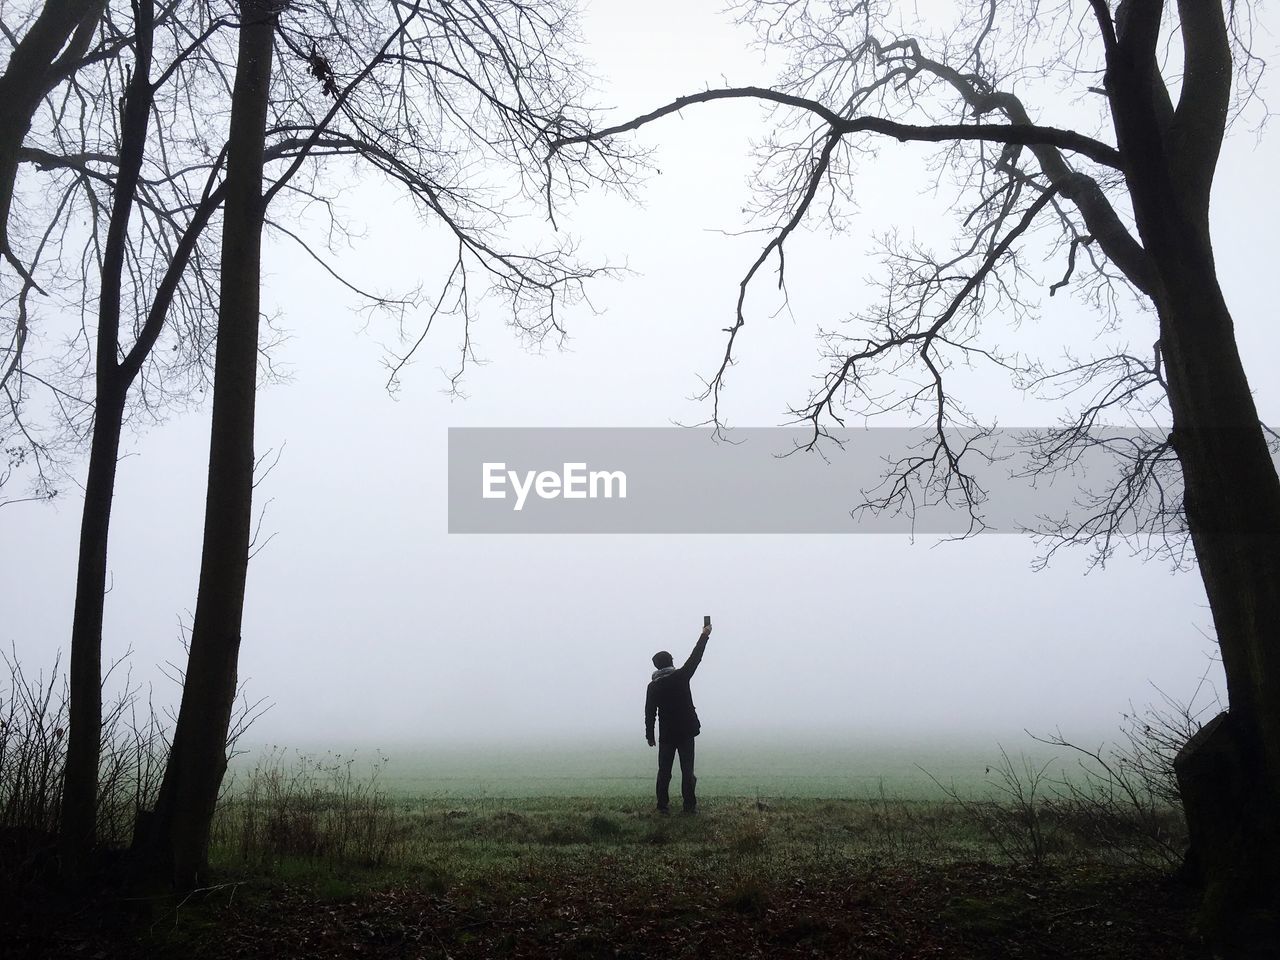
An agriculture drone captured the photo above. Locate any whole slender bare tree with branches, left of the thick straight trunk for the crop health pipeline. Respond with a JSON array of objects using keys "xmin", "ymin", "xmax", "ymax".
[{"xmin": 38, "ymin": 0, "xmax": 240, "ymax": 869}]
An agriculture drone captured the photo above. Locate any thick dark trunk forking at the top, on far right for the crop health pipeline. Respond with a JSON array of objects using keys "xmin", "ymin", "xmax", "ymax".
[{"xmin": 1105, "ymin": 9, "xmax": 1280, "ymax": 957}]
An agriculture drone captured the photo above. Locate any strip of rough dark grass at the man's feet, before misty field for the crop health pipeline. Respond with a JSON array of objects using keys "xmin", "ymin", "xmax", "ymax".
[{"xmin": 212, "ymin": 797, "xmax": 1070, "ymax": 886}]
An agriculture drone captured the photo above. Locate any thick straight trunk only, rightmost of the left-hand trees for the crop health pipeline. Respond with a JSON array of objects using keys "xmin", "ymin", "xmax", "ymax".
[{"xmin": 146, "ymin": 0, "xmax": 276, "ymax": 888}]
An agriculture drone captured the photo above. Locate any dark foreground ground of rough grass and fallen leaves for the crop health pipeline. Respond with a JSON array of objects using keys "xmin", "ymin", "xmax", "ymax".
[{"xmin": 4, "ymin": 799, "xmax": 1201, "ymax": 960}]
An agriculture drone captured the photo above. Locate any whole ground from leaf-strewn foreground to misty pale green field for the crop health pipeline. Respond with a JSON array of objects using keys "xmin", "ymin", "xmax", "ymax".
[{"xmin": 5, "ymin": 741, "xmax": 1201, "ymax": 960}]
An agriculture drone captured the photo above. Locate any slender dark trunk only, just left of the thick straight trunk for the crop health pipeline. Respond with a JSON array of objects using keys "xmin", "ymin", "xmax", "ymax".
[{"xmin": 60, "ymin": 0, "xmax": 155, "ymax": 873}]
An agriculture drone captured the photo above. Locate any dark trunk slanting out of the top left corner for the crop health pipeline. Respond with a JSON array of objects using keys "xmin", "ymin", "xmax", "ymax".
[{"xmin": 0, "ymin": 0, "xmax": 106, "ymax": 253}]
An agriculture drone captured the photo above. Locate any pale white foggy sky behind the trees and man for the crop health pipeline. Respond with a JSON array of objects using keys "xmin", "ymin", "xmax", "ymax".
[{"xmin": 0, "ymin": 0, "xmax": 1280, "ymax": 745}]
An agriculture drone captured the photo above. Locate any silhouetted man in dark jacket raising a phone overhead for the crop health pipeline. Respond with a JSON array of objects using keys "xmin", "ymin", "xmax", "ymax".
[{"xmin": 644, "ymin": 623, "xmax": 712, "ymax": 813}]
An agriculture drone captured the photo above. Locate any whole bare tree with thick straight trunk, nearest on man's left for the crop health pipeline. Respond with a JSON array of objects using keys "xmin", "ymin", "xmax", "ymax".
[{"xmin": 135, "ymin": 0, "xmax": 609, "ymax": 887}]
